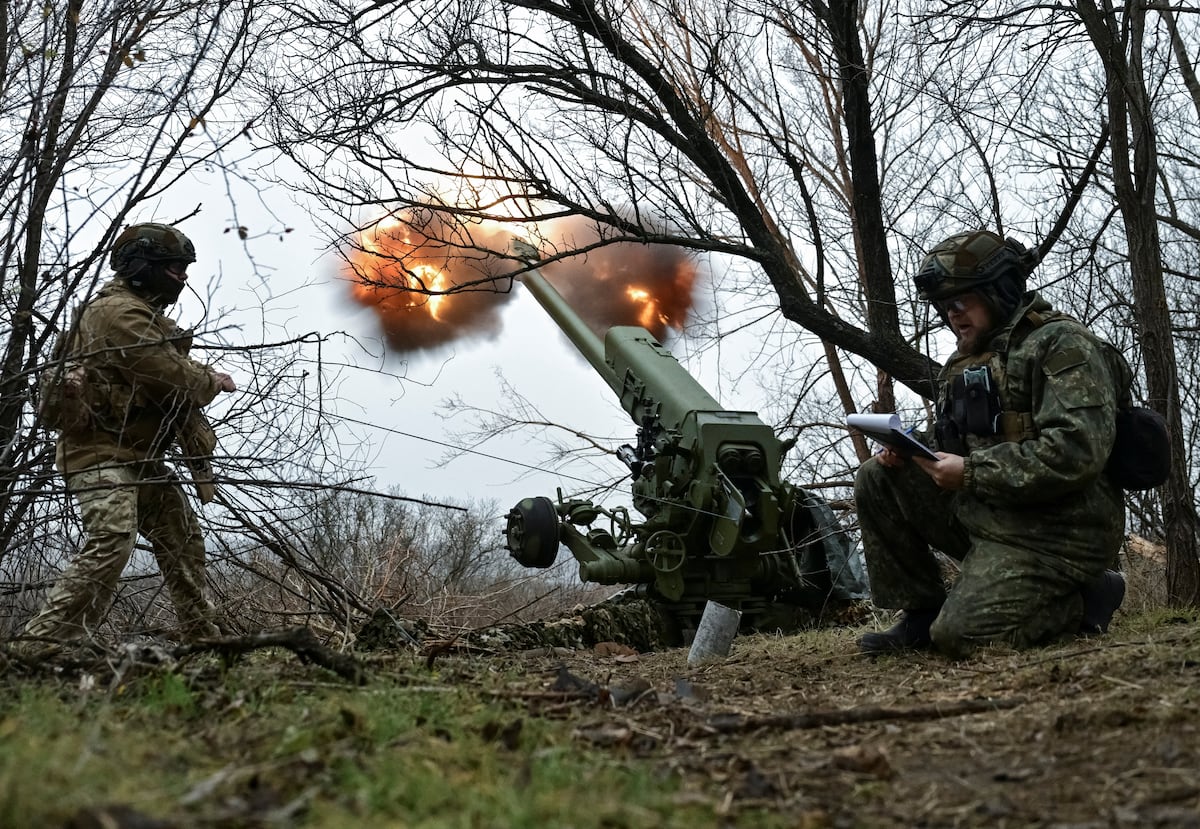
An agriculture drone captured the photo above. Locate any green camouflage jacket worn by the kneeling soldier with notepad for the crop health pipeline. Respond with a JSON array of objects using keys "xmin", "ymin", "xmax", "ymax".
[{"xmin": 938, "ymin": 292, "xmax": 1129, "ymax": 556}]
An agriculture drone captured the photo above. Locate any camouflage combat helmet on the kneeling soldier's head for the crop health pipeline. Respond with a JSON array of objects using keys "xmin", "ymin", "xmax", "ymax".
[{"xmin": 912, "ymin": 230, "xmax": 1038, "ymax": 319}]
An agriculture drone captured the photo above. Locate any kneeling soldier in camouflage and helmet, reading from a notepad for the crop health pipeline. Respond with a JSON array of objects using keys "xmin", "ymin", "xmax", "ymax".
[{"xmin": 854, "ymin": 230, "xmax": 1130, "ymax": 656}]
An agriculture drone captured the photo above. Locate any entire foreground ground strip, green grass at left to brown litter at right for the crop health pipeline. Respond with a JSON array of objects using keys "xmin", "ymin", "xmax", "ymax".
[{"xmin": 0, "ymin": 583, "xmax": 1200, "ymax": 829}]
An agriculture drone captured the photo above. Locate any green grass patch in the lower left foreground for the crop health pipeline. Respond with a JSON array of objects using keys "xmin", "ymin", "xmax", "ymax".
[{"xmin": 0, "ymin": 655, "xmax": 770, "ymax": 828}]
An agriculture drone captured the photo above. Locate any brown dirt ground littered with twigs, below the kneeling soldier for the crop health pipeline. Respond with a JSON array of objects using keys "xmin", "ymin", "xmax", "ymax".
[{"xmin": 477, "ymin": 613, "xmax": 1200, "ymax": 829}]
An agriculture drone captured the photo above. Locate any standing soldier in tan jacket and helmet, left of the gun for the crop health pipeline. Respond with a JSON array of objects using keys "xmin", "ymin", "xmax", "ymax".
[{"xmin": 25, "ymin": 223, "xmax": 236, "ymax": 641}]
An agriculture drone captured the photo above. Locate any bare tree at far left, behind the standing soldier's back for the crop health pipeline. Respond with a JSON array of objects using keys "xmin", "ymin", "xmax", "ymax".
[{"xmin": 0, "ymin": 1, "xmax": 260, "ymax": 549}]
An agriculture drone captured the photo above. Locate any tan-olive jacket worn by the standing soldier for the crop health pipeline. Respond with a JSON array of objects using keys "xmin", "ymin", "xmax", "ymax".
[{"xmin": 56, "ymin": 278, "xmax": 220, "ymax": 473}]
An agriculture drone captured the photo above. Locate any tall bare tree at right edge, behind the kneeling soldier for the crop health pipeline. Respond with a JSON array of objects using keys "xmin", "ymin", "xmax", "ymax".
[{"xmin": 907, "ymin": 0, "xmax": 1200, "ymax": 605}]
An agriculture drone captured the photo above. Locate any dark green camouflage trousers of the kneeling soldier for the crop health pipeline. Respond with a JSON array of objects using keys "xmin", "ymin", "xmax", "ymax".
[{"xmin": 854, "ymin": 458, "xmax": 1124, "ymax": 656}]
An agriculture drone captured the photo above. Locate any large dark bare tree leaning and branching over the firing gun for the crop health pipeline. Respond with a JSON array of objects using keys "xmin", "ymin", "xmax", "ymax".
[{"xmin": 264, "ymin": 0, "xmax": 945, "ymax": 389}]
